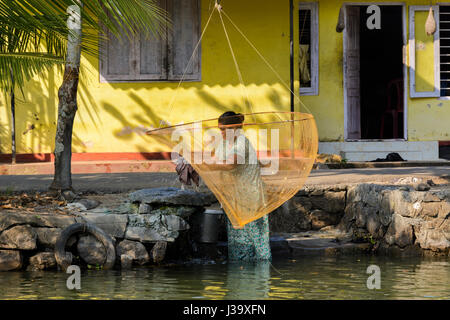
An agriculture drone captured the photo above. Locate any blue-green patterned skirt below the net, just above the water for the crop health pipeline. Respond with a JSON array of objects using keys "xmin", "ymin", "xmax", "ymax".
[{"xmin": 228, "ymin": 215, "xmax": 272, "ymax": 262}]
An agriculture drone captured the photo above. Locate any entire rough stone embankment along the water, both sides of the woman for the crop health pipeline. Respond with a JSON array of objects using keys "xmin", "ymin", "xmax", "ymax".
[{"xmin": 0, "ymin": 184, "xmax": 450, "ymax": 271}]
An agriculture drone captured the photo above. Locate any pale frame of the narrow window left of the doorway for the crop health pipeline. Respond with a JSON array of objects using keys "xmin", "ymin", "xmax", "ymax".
[{"xmin": 297, "ymin": 2, "xmax": 319, "ymax": 96}]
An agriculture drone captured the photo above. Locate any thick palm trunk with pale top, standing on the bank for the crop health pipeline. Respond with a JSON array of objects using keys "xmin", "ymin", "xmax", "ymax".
[{"xmin": 50, "ymin": 3, "xmax": 82, "ymax": 191}]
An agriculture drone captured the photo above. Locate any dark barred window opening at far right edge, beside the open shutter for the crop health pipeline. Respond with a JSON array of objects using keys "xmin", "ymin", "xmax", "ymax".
[{"xmin": 439, "ymin": 6, "xmax": 450, "ymax": 97}]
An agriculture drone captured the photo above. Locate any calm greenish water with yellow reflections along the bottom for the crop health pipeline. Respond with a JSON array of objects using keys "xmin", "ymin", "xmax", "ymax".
[{"xmin": 0, "ymin": 256, "xmax": 450, "ymax": 300}]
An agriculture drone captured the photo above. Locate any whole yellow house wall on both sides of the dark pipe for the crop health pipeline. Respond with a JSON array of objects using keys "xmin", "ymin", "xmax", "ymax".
[{"xmin": 0, "ymin": 0, "xmax": 450, "ymax": 153}]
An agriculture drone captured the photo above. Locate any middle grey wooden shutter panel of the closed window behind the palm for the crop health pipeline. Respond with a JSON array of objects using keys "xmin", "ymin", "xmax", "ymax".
[{"xmin": 135, "ymin": 0, "xmax": 168, "ymax": 80}]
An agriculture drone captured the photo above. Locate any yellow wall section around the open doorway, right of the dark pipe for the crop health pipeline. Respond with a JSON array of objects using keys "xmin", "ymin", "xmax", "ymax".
[{"xmin": 296, "ymin": 0, "xmax": 450, "ymax": 141}]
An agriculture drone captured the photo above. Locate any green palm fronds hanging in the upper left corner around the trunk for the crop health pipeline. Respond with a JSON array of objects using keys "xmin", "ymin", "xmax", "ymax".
[{"xmin": 0, "ymin": 0, "xmax": 169, "ymax": 90}]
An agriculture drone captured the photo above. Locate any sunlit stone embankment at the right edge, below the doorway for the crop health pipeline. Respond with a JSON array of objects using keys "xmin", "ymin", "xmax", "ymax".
[{"xmin": 339, "ymin": 184, "xmax": 450, "ymax": 254}]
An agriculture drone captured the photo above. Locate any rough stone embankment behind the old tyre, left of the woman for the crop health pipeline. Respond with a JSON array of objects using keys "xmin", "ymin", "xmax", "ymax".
[{"xmin": 0, "ymin": 188, "xmax": 216, "ymax": 271}]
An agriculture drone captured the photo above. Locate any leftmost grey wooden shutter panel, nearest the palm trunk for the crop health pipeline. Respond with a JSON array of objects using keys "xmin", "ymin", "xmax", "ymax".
[{"xmin": 100, "ymin": 21, "xmax": 135, "ymax": 82}]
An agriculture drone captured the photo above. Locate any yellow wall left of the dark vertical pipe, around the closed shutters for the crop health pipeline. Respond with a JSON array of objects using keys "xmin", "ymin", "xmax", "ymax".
[{"xmin": 0, "ymin": 0, "xmax": 290, "ymax": 153}]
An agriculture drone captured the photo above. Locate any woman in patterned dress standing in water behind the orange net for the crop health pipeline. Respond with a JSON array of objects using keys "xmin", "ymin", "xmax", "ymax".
[{"xmin": 204, "ymin": 111, "xmax": 272, "ymax": 261}]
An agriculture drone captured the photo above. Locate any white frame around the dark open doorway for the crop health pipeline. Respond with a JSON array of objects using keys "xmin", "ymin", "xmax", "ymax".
[{"xmin": 343, "ymin": 1, "xmax": 408, "ymax": 141}]
